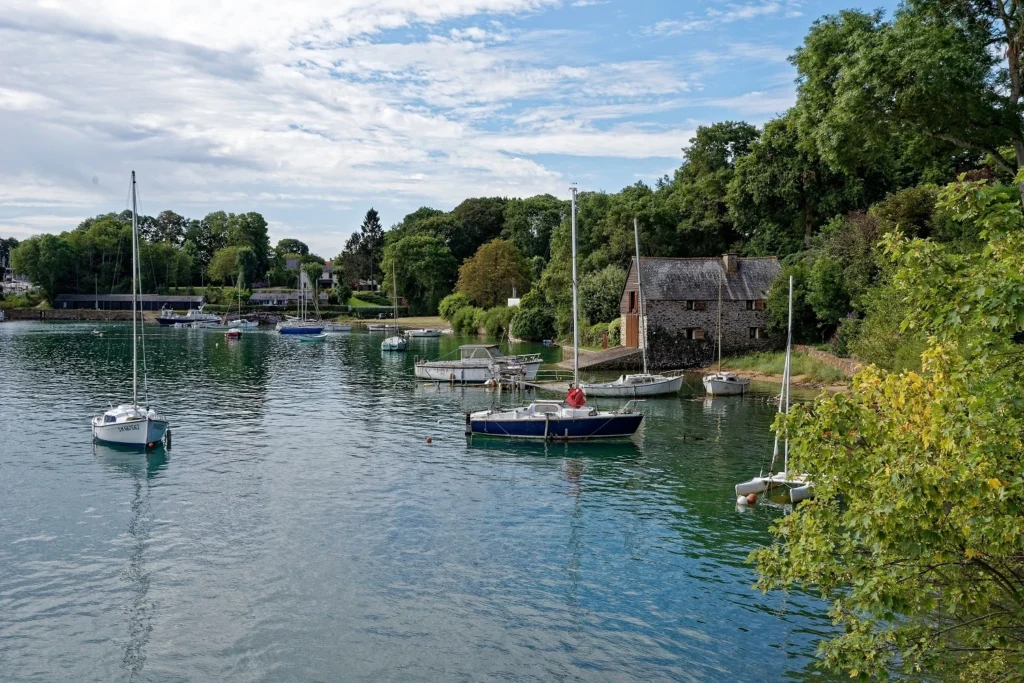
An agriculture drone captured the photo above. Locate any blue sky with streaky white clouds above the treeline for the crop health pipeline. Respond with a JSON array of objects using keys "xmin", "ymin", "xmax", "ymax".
[{"xmin": 0, "ymin": 0, "xmax": 895, "ymax": 258}]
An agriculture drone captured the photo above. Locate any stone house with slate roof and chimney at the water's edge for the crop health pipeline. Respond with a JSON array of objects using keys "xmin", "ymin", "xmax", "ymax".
[{"xmin": 618, "ymin": 254, "xmax": 782, "ymax": 370}]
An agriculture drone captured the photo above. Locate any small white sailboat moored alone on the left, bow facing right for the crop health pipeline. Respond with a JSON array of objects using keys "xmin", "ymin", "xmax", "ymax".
[{"xmin": 92, "ymin": 171, "xmax": 167, "ymax": 449}]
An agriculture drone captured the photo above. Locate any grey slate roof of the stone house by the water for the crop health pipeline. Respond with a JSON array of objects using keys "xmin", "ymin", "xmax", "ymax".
[{"xmin": 630, "ymin": 256, "xmax": 782, "ymax": 301}]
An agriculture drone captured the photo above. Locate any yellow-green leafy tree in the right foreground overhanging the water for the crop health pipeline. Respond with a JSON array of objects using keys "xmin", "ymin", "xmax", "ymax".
[{"xmin": 756, "ymin": 183, "xmax": 1024, "ymax": 681}]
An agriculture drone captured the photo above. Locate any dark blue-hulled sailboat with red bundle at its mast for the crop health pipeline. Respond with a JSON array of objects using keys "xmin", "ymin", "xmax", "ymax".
[{"xmin": 466, "ymin": 185, "xmax": 643, "ymax": 441}]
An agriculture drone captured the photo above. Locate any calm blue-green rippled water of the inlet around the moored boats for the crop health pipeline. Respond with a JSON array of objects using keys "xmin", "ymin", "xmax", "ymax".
[{"xmin": 0, "ymin": 323, "xmax": 829, "ymax": 681}]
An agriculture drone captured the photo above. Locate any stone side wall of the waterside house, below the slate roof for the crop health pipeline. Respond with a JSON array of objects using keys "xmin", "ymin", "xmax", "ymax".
[{"xmin": 646, "ymin": 301, "xmax": 784, "ymax": 370}]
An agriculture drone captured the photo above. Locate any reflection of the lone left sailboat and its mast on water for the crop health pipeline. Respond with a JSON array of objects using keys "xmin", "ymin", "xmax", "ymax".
[{"xmin": 92, "ymin": 442, "xmax": 168, "ymax": 679}]
